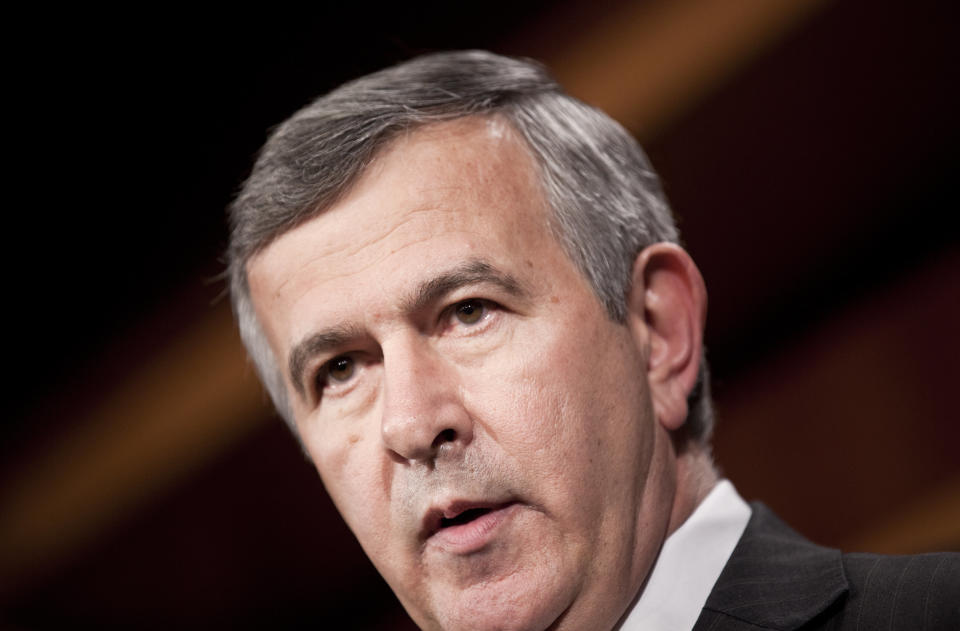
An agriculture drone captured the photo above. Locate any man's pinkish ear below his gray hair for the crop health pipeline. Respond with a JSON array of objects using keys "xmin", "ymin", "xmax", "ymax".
[{"xmin": 627, "ymin": 243, "xmax": 707, "ymax": 431}]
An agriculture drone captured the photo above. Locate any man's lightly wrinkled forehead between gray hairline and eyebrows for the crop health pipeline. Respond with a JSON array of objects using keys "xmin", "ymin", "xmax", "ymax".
[{"xmin": 248, "ymin": 117, "xmax": 560, "ymax": 340}]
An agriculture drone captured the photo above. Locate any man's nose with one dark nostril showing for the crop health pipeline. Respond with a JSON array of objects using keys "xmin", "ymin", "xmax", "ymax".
[{"xmin": 380, "ymin": 344, "xmax": 473, "ymax": 462}]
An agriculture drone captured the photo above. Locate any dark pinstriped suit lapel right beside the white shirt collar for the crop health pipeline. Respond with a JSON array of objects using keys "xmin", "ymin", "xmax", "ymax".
[{"xmin": 694, "ymin": 503, "xmax": 849, "ymax": 631}]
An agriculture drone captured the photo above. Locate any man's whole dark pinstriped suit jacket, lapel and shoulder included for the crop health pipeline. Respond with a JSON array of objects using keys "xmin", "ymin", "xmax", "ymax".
[{"xmin": 694, "ymin": 504, "xmax": 960, "ymax": 631}]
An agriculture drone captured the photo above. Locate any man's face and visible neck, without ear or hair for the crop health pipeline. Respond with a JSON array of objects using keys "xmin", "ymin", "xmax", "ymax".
[{"xmin": 249, "ymin": 118, "xmax": 674, "ymax": 629}]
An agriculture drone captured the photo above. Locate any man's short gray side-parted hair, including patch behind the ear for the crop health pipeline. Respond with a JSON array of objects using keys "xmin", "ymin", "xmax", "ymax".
[{"xmin": 227, "ymin": 51, "xmax": 713, "ymax": 443}]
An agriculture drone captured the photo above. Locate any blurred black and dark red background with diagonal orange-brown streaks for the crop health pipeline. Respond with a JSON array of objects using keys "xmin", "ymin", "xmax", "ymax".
[{"xmin": 0, "ymin": 0, "xmax": 960, "ymax": 629}]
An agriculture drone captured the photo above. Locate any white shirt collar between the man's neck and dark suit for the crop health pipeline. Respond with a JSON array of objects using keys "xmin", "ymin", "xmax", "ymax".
[{"xmin": 619, "ymin": 480, "xmax": 750, "ymax": 631}]
